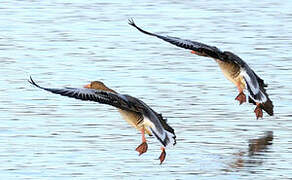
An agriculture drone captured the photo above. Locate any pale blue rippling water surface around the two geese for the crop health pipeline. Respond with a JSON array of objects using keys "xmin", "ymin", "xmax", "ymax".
[{"xmin": 0, "ymin": 0, "xmax": 292, "ymax": 179}]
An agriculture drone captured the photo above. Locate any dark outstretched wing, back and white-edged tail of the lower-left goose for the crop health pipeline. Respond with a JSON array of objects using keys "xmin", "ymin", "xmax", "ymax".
[{"xmin": 28, "ymin": 77, "xmax": 176, "ymax": 146}]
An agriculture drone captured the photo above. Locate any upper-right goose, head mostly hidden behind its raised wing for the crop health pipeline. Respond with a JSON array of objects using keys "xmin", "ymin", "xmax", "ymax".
[{"xmin": 129, "ymin": 19, "xmax": 274, "ymax": 119}]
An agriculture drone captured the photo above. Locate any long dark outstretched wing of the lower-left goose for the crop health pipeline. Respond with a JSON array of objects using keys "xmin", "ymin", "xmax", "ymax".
[{"xmin": 29, "ymin": 77, "xmax": 141, "ymax": 112}]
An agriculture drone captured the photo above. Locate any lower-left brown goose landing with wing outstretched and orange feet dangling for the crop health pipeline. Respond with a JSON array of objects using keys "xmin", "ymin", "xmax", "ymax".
[{"xmin": 29, "ymin": 77, "xmax": 176, "ymax": 164}]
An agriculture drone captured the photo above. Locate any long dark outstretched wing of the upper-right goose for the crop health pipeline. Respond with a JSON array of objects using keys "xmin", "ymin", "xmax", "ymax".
[{"xmin": 129, "ymin": 19, "xmax": 222, "ymax": 59}]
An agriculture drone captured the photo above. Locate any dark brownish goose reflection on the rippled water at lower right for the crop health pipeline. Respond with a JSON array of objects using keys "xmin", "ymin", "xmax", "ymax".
[{"xmin": 228, "ymin": 131, "xmax": 274, "ymax": 171}]
